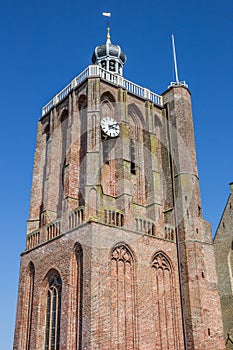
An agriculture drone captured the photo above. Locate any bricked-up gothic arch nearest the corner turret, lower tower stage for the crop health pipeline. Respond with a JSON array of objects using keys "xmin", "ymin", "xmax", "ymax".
[{"xmin": 151, "ymin": 252, "xmax": 180, "ymax": 350}]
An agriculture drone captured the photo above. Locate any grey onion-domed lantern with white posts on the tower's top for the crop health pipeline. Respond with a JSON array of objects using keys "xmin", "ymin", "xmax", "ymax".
[{"xmin": 92, "ymin": 27, "xmax": 126, "ymax": 75}]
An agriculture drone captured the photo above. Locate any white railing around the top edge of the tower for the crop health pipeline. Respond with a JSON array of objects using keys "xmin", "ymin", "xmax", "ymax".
[{"xmin": 42, "ymin": 65, "xmax": 163, "ymax": 116}]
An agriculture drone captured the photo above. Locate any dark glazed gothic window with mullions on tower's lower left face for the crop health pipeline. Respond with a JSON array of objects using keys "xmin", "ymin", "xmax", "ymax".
[{"xmin": 44, "ymin": 273, "xmax": 62, "ymax": 350}]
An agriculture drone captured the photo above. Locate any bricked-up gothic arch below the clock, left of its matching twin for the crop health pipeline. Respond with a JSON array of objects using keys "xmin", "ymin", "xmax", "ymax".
[{"xmin": 111, "ymin": 244, "xmax": 137, "ymax": 350}]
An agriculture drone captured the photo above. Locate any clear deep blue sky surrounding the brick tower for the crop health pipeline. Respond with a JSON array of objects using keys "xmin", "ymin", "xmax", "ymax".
[{"xmin": 0, "ymin": 0, "xmax": 233, "ymax": 350}]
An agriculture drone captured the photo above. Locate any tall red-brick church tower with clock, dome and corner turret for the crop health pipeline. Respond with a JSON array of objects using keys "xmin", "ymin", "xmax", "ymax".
[{"xmin": 14, "ymin": 28, "xmax": 225, "ymax": 350}]
